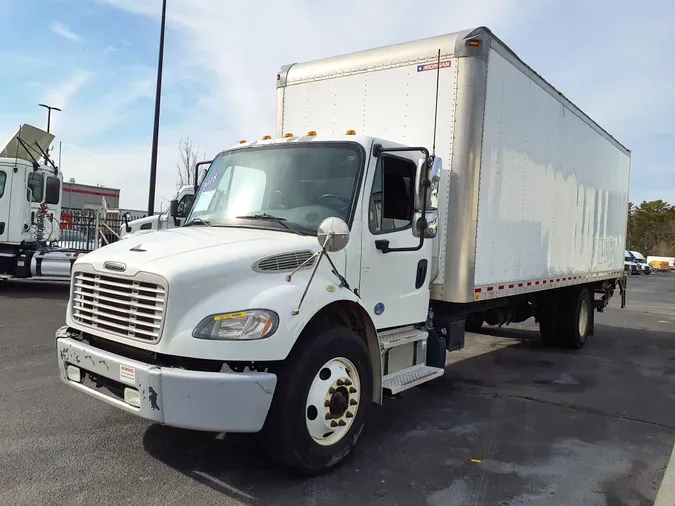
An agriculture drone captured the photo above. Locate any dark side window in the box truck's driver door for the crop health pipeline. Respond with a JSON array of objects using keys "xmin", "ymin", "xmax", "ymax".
[{"xmin": 368, "ymin": 156, "xmax": 416, "ymax": 234}]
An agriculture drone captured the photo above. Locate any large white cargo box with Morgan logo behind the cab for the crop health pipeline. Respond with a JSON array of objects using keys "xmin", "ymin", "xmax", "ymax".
[{"xmin": 276, "ymin": 28, "xmax": 630, "ymax": 303}]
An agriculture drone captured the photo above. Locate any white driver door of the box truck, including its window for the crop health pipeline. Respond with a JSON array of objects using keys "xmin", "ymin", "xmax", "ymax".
[{"xmin": 360, "ymin": 146, "xmax": 432, "ymax": 330}]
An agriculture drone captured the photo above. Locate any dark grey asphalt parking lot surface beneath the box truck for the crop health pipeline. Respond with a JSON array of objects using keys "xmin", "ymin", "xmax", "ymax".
[{"xmin": 0, "ymin": 274, "xmax": 675, "ymax": 506}]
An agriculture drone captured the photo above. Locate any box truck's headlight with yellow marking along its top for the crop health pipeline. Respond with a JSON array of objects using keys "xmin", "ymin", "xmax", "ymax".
[{"xmin": 192, "ymin": 309, "xmax": 279, "ymax": 340}]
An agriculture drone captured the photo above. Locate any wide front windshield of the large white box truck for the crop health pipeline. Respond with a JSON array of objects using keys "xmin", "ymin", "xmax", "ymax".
[{"xmin": 187, "ymin": 142, "xmax": 363, "ymax": 233}]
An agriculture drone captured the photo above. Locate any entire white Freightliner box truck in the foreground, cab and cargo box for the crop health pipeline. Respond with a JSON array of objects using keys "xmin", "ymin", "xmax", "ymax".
[{"xmin": 56, "ymin": 28, "xmax": 630, "ymax": 473}]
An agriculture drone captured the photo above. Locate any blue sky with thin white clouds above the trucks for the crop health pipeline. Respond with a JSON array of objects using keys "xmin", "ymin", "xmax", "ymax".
[{"xmin": 0, "ymin": 0, "xmax": 675, "ymax": 209}]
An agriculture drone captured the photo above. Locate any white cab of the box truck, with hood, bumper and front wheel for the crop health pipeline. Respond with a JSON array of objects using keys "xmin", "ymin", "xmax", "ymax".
[{"xmin": 57, "ymin": 133, "xmax": 445, "ymax": 472}]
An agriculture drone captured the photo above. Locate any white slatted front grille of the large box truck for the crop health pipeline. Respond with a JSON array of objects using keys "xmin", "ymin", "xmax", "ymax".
[{"xmin": 72, "ymin": 272, "xmax": 166, "ymax": 341}]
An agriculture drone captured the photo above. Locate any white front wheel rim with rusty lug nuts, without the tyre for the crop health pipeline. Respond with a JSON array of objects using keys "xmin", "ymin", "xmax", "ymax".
[{"xmin": 305, "ymin": 357, "xmax": 361, "ymax": 446}]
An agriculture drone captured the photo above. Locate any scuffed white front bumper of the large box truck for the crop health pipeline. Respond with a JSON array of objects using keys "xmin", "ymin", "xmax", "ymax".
[{"xmin": 56, "ymin": 327, "xmax": 277, "ymax": 432}]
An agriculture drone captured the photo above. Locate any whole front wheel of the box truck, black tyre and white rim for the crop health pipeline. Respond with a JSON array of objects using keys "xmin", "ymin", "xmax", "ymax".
[{"xmin": 265, "ymin": 328, "xmax": 373, "ymax": 475}]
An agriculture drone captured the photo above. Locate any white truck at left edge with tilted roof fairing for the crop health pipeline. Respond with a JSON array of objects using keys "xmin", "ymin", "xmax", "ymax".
[{"xmin": 0, "ymin": 124, "xmax": 90, "ymax": 280}]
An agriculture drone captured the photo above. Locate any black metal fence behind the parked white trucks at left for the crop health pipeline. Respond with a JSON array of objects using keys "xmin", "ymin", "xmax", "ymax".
[{"xmin": 57, "ymin": 209, "xmax": 124, "ymax": 251}]
